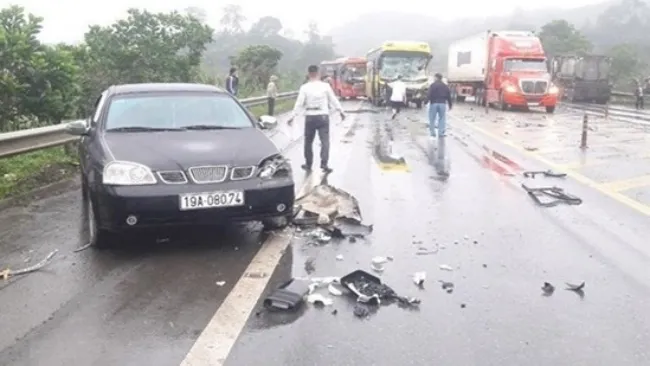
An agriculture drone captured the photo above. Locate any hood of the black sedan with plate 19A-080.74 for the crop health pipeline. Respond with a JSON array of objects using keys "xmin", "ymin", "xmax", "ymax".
[{"xmin": 103, "ymin": 128, "xmax": 279, "ymax": 170}]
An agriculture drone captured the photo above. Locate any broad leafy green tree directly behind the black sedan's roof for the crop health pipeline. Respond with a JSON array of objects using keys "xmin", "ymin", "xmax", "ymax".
[{"xmin": 80, "ymin": 9, "xmax": 213, "ymax": 88}]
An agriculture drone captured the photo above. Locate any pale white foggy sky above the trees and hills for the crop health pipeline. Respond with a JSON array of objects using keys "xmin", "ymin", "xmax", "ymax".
[{"xmin": 0, "ymin": 0, "xmax": 601, "ymax": 43}]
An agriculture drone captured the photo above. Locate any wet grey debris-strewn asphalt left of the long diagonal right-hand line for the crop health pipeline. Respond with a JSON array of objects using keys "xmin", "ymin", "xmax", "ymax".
[{"xmin": 0, "ymin": 101, "xmax": 650, "ymax": 365}]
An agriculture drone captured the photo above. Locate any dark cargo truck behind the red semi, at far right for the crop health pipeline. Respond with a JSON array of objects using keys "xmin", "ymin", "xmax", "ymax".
[{"xmin": 551, "ymin": 55, "xmax": 612, "ymax": 104}]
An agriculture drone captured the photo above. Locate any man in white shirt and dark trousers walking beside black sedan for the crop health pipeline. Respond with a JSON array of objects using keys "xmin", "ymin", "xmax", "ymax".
[{"xmin": 287, "ymin": 65, "xmax": 345, "ymax": 173}]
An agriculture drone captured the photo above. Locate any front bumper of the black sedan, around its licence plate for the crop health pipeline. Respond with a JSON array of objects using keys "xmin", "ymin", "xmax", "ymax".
[{"xmin": 92, "ymin": 178, "xmax": 295, "ymax": 231}]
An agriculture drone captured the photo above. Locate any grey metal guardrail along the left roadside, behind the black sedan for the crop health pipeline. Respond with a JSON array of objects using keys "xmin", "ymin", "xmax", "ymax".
[{"xmin": 0, "ymin": 91, "xmax": 298, "ymax": 158}]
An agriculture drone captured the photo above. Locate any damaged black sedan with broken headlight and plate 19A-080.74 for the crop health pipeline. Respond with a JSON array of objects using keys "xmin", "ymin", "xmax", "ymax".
[{"xmin": 67, "ymin": 84, "xmax": 295, "ymax": 246}]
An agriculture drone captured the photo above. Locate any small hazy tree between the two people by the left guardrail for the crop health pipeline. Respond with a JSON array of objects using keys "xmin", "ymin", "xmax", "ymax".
[{"xmin": 233, "ymin": 45, "xmax": 282, "ymax": 88}]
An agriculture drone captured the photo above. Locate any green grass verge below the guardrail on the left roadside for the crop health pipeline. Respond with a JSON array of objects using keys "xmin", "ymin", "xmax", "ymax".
[{"xmin": 0, "ymin": 99, "xmax": 295, "ymax": 200}]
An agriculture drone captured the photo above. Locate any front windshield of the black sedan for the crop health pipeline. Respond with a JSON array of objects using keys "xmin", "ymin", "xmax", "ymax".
[{"xmin": 104, "ymin": 93, "xmax": 254, "ymax": 132}]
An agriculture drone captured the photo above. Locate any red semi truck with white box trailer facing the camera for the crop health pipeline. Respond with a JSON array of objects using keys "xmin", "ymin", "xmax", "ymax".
[{"xmin": 447, "ymin": 31, "xmax": 559, "ymax": 113}]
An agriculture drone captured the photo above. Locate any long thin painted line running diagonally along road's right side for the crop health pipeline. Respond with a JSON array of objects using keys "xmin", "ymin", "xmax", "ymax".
[{"xmin": 452, "ymin": 117, "xmax": 650, "ymax": 216}]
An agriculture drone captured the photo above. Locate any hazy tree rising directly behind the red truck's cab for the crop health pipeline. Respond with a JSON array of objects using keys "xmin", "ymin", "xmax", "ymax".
[{"xmin": 539, "ymin": 19, "xmax": 593, "ymax": 56}]
